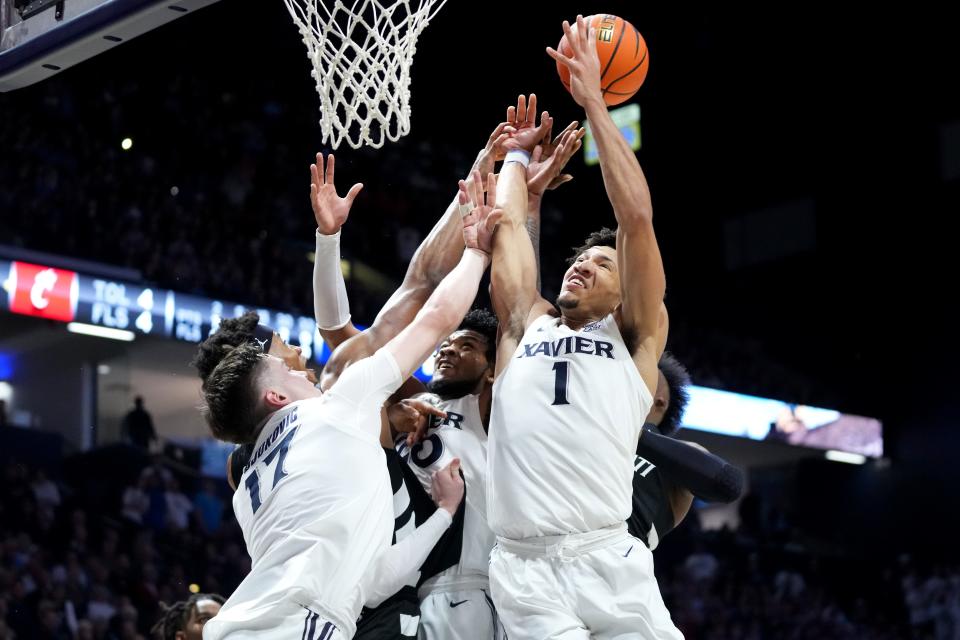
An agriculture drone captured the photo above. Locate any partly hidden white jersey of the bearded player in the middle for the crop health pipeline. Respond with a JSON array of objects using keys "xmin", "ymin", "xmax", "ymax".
[{"xmin": 397, "ymin": 395, "xmax": 497, "ymax": 592}]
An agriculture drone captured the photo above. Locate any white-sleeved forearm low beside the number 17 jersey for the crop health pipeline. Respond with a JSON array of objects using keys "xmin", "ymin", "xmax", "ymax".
[{"xmin": 366, "ymin": 509, "xmax": 453, "ymax": 607}]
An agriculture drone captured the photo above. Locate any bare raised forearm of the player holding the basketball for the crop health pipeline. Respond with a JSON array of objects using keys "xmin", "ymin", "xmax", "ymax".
[{"xmin": 586, "ymin": 98, "xmax": 653, "ymax": 229}]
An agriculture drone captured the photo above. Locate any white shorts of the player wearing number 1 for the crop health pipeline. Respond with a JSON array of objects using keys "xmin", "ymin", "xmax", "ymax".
[{"xmin": 490, "ymin": 525, "xmax": 683, "ymax": 640}]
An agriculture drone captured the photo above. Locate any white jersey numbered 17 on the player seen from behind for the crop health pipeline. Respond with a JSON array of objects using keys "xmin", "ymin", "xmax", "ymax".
[{"xmin": 203, "ymin": 349, "xmax": 401, "ymax": 640}]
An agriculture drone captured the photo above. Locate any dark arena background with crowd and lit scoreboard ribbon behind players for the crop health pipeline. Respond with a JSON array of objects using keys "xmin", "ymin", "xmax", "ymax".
[{"xmin": 0, "ymin": 0, "xmax": 960, "ymax": 640}]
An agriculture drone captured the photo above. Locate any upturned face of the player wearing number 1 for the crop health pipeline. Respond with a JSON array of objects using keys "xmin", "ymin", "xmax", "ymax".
[{"xmin": 557, "ymin": 247, "xmax": 620, "ymax": 315}]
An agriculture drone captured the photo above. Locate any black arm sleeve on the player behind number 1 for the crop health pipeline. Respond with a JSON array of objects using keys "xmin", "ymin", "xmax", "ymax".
[{"xmin": 637, "ymin": 426, "xmax": 743, "ymax": 502}]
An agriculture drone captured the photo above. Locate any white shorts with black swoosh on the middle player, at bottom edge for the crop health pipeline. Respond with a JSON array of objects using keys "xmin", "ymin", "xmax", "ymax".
[{"xmin": 417, "ymin": 589, "xmax": 506, "ymax": 640}]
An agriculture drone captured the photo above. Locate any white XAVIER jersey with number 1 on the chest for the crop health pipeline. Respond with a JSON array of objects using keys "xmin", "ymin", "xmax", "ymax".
[{"xmin": 487, "ymin": 315, "xmax": 653, "ymax": 539}]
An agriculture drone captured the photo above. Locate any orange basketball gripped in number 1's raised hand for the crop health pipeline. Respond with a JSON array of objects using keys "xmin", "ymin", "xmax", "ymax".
[{"xmin": 557, "ymin": 14, "xmax": 650, "ymax": 106}]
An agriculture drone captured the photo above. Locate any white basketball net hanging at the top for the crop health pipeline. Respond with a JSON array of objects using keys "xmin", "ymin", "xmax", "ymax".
[{"xmin": 284, "ymin": 0, "xmax": 446, "ymax": 149}]
